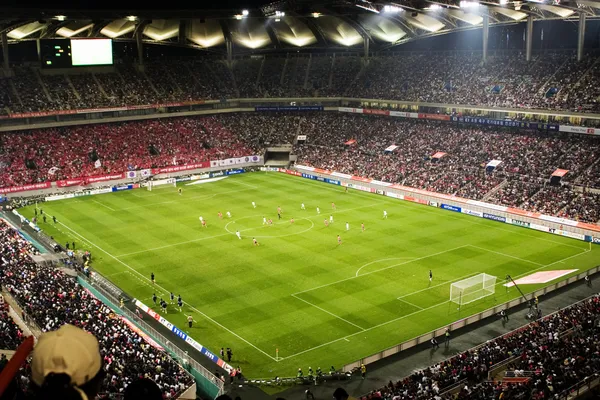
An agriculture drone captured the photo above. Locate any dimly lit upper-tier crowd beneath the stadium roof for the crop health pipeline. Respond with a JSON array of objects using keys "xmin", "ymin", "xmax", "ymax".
[{"xmin": 0, "ymin": 52, "xmax": 600, "ymax": 113}]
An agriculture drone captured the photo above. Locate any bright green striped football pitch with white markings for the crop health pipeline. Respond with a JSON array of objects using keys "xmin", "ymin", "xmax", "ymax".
[{"xmin": 23, "ymin": 172, "xmax": 600, "ymax": 378}]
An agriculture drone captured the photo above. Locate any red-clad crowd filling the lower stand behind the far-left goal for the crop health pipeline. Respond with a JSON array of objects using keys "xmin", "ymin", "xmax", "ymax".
[{"xmin": 0, "ymin": 117, "xmax": 256, "ymax": 187}]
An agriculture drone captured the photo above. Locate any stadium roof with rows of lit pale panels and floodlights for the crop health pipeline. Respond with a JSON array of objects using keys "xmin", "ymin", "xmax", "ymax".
[{"xmin": 0, "ymin": 0, "xmax": 600, "ymax": 50}]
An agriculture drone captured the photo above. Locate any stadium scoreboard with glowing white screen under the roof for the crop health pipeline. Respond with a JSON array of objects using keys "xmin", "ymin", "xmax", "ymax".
[{"xmin": 39, "ymin": 39, "xmax": 113, "ymax": 68}]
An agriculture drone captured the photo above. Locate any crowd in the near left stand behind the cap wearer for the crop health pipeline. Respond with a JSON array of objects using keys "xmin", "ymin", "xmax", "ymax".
[{"xmin": 0, "ymin": 221, "xmax": 193, "ymax": 398}]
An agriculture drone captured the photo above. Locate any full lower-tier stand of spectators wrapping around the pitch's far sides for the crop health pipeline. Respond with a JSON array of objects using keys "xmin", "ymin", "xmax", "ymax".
[{"xmin": 0, "ymin": 112, "xmax": 600, "ymax": 223}]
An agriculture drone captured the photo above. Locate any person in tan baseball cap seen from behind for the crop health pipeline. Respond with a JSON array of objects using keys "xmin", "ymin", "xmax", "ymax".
[{"xmin": 31, "ymin": 324, "xmax": 105, "ymax": 400}]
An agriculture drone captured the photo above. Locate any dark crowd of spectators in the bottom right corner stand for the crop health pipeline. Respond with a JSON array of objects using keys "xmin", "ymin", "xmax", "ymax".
[{"xmin": 361, "ymin": 296, "xmax": 600, "ymax": 400}]
